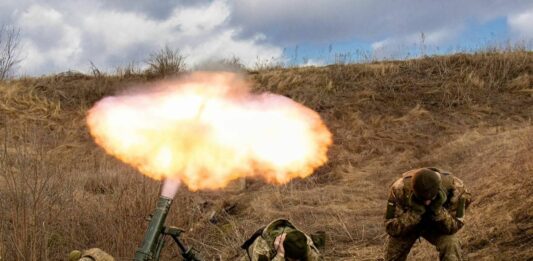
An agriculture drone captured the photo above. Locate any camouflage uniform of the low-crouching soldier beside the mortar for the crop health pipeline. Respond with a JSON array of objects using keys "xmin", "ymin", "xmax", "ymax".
[{"xmin": 241, "ymin": 219, "xmax": 323, "ymax": 261}]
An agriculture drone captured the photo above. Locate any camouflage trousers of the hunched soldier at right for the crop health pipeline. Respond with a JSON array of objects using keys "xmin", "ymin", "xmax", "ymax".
[{"xmin": 385, "ymin": 233, "xmax": 463, "ymax": 261}]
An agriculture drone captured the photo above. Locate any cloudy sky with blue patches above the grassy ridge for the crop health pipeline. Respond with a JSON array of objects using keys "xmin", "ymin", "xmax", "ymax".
[{"xmin": 0, "ymin": 0, "xmax": 533, "ymax": 75}]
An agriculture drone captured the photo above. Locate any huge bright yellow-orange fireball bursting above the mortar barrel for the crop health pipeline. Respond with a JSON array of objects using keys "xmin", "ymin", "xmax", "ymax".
[{"xmin": 87, "ymin": 72, "xmax": 332, "ymax": 191}]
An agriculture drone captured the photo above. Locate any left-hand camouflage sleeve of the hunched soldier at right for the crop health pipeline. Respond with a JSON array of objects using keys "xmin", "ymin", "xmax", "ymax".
[{"xmin": 385, "ymin": 188, "xmax": 422, "ymax": 237}]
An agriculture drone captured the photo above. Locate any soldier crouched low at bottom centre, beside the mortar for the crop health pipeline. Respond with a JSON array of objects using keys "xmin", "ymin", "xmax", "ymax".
[{"xmin": 241, "ymin": 219, "xmax": 325, "ymax": 261}]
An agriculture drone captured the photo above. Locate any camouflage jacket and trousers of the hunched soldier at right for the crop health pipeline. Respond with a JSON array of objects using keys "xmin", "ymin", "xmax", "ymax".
[{"xmin": 385, "ymin": 168, "xmax": 471, "ymax": 260}]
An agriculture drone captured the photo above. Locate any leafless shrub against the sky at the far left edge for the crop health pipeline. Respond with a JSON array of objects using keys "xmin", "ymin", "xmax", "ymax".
[{"xmin": 0, "ymin": 25, "xmax": 20, "ymax": 80}]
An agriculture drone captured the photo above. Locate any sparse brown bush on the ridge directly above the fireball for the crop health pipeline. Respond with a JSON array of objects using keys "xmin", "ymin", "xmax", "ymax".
[{"xmin": 146, "ymin": 46, "xmax": 185, "ymax": 77}]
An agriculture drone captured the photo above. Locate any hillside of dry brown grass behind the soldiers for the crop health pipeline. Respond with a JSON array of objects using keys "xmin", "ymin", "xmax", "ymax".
[{"xmin": 0, "ymin": 52, "xmax": 533, "ymax": 260}]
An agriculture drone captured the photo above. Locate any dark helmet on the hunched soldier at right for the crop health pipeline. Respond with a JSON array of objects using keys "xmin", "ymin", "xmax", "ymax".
[{"xmin": 412, "ymin": 169, "xmax": 441, "ymax": 200}]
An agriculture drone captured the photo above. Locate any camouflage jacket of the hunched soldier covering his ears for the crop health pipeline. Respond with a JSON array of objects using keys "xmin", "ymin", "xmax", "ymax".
[{"xmin": 385, "ymin": 168, "xmax": 471, "ymax": 237}]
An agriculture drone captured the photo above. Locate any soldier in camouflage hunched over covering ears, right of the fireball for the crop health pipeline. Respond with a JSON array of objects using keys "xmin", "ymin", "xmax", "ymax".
[{"xmin": 385, "ymin": 168, "xmax": 471, "ymax": 260}]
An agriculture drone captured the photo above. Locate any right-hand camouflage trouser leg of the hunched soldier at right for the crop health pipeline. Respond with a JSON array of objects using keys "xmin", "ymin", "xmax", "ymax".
[{"xmin": 424, "ymin": 234, "xmax": 463, "ymax": 261}]
